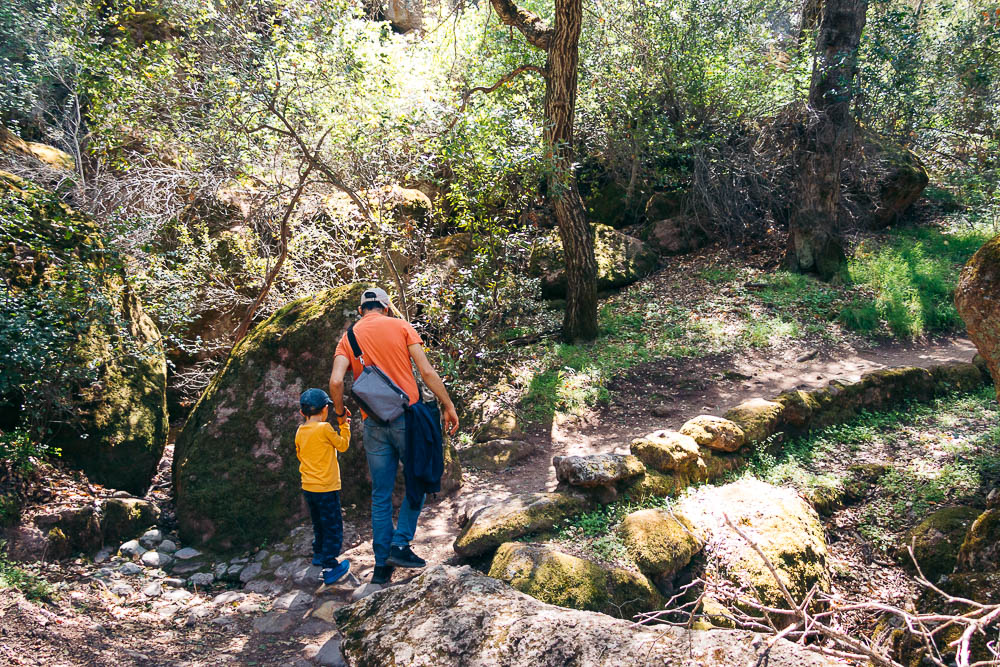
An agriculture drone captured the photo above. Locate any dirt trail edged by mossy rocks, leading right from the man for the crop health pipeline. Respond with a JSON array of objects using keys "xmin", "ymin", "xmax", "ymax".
[{"xmin": 380, "ymin": 337, "xmax": 976, "ymax": 574}]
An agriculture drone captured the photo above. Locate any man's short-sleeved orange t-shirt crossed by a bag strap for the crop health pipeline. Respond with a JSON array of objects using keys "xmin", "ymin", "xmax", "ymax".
[{"xmin": 334, "ymin": 313, "xmax": 423, "ymax": 412}]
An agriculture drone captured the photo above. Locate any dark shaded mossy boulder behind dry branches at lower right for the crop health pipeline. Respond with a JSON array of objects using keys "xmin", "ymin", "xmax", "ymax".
[{"xmin": 896, "ymin": 507, "xmax": 980, "ymax": 583}]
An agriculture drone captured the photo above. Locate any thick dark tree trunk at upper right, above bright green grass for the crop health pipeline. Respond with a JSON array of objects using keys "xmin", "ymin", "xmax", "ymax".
[{"xmin": 787, "ymin": 0, "xmax": 868, "ymax": 280}]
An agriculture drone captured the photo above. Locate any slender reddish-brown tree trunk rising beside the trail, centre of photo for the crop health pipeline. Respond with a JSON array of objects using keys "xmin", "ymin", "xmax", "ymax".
[{"xmin": 545, "ymin": 0, "xmax": 597, "ymax": 342}]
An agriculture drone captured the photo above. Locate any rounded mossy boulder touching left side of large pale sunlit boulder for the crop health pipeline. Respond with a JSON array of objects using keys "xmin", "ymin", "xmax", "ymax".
[{"xmin": 619, "ymin": 509, "xmax": 702, "ymax": 578}]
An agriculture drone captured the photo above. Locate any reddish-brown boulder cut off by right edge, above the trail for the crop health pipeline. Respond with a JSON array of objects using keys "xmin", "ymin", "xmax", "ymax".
[{"xmin": 955, "ymin": 236, "xmax": 1000, "ymax": 400}]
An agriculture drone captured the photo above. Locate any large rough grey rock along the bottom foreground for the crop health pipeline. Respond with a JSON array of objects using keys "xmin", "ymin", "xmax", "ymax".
[{"xmin": 336, "ymin": 565, "xmax": 840, "ymax": 667}]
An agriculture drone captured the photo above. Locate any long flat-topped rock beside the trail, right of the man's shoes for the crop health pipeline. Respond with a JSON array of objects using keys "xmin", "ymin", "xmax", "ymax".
[{"xmin": 454, "ymin": 493, "xmax": 588, "ymax": 558}]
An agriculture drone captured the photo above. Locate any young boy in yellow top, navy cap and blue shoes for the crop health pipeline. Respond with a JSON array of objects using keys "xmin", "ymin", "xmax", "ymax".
[{"xmin": 295, "ymin": 389, "xmax": 351, "ymax": 586}]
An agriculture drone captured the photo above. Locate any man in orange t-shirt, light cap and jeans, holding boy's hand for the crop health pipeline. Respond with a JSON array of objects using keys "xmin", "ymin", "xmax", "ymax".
[{"xmin": 330, "ymin": 287, "xmax": 458, "ymax": 584}]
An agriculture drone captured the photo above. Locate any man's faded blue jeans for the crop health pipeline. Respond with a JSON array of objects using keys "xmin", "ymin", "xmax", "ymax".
[{"xmin": 364, "ymin": 415, "xmax": 423, "ymax": 566}]
